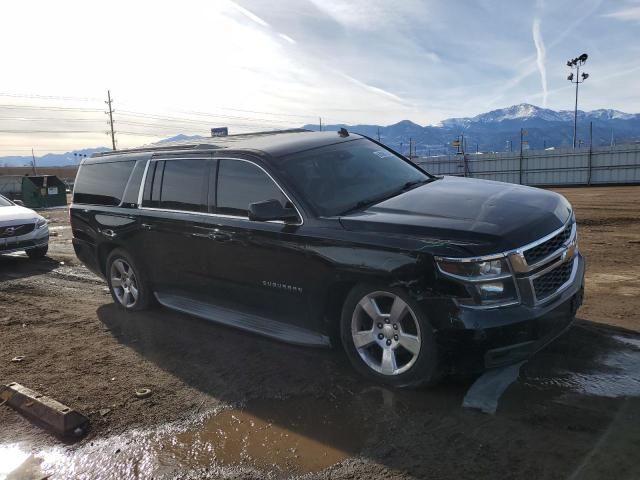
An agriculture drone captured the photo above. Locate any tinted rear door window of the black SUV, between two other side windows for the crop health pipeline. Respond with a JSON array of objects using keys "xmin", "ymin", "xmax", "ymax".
[{"xmin": 142, "ymin": 160, "xmax": 209, "ymax": 212}]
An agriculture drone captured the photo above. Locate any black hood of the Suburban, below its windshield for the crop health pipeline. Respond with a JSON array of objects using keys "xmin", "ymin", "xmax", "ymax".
[{"xmin": 340, "ymin": 177, "xmax": 571, "ymax": 256}]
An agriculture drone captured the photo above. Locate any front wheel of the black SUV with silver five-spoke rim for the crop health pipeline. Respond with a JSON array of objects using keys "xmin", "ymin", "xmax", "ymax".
[{"xmin": 340, "ymin": 285, "xmax": 441, "ymax": 388}]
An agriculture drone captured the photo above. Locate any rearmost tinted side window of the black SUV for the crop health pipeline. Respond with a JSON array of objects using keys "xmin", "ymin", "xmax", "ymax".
[{"xmin": 73, "ymin": 160, "xmax": 135, "ymax": 206}]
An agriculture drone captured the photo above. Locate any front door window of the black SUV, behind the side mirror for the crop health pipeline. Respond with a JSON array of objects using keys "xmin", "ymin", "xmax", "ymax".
[{"xmin": 217, "ymin": 160, "xmax": 287, "ymax": 217}]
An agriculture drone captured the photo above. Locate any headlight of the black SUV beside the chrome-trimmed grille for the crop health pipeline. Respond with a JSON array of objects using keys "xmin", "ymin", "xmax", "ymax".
[{"xmin": 436, "ymin": 257, "xmax": 518, "ymax": 307}]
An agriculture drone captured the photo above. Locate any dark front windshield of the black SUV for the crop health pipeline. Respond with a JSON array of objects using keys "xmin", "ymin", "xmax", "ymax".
[{"xmin": 278, "ymin": 139, "xmax": 434, "ymax": 216}]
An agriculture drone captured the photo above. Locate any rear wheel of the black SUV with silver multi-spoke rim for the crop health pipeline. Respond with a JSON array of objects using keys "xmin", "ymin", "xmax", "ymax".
[{"xmin": 105, "ymin": 248, "xmax": 153, "ymax": 311}]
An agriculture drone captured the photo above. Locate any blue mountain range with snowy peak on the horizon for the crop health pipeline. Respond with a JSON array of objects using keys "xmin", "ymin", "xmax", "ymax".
[{"xmin": 0, "ymin": 103, "xmax": 640, "ymax": 166}]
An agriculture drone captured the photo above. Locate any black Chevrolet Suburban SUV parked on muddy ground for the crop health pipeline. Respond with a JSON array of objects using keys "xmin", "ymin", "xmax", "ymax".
[{"xmin": 71, "ymin": 130, "xmax": 584, "ymax": 387}]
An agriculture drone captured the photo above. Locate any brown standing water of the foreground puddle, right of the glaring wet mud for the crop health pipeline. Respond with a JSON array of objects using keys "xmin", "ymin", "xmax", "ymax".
[{"xmin": 158, "ymin": 399, "xmax": 364, "ymax": 473}]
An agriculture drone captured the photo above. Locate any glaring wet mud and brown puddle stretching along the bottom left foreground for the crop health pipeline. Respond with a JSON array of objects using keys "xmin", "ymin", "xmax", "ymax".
[{"xmin": 8, "ymin": 398, "xmax": 368, "ymax": 479}]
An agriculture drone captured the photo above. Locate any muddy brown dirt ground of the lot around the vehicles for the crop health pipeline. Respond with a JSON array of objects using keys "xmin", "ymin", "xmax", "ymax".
[{"xmin": 0, "ymin": 187, "xmax": 640, "ymax": 479}]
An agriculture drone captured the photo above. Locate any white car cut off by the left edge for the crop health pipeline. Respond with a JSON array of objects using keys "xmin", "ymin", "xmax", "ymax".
[{"xmin": 0, "ymin": 195, "xmax": 49, "ymax": 258}]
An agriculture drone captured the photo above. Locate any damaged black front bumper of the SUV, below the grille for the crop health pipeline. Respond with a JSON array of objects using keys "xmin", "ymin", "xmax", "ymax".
[{"xmin": 438, "ymin": 253, "xmax": 585, "ymax": 372}]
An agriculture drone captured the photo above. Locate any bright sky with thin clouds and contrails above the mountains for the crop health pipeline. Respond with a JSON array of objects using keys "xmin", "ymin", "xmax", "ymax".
[{"xmin": 0, "ymin": 0, "xmax": 640, "ymax": 155}]
